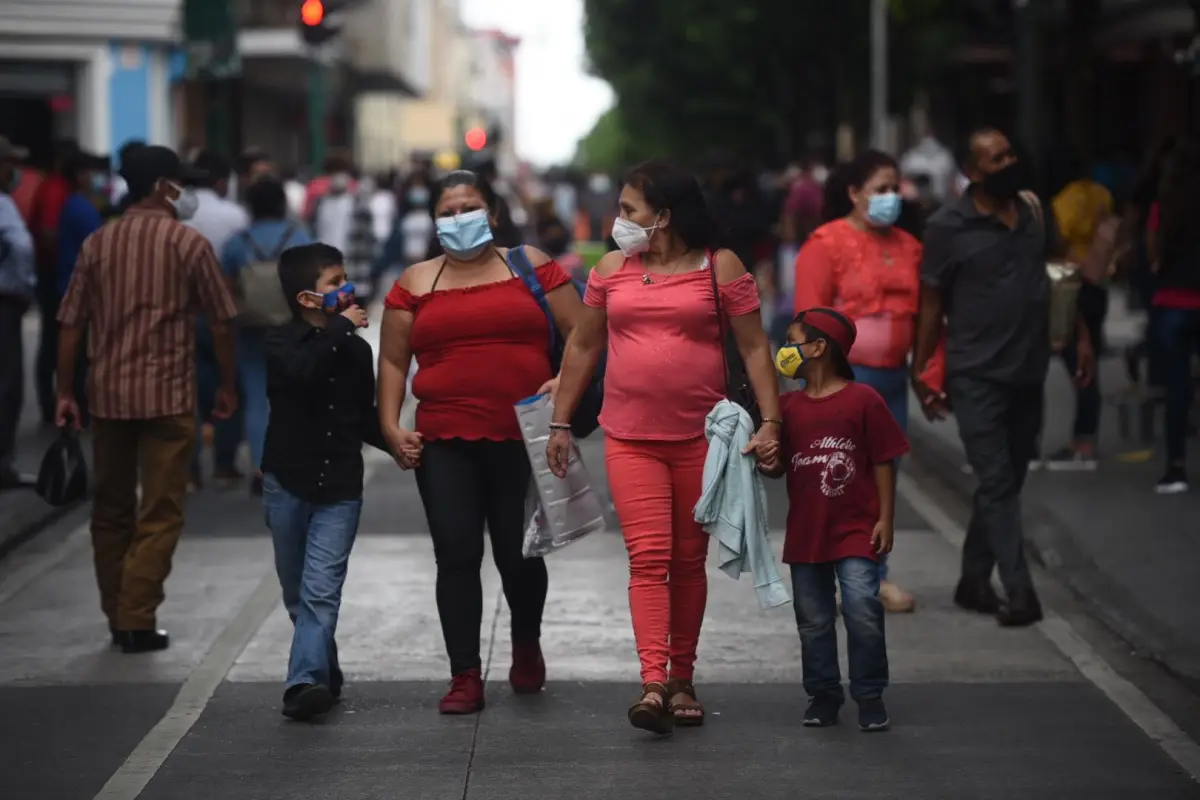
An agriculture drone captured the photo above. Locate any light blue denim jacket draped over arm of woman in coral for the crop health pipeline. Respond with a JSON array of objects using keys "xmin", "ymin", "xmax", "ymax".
[{"xmin": 694, "ymin": 401, "xmax": 791, "ymax": 608}]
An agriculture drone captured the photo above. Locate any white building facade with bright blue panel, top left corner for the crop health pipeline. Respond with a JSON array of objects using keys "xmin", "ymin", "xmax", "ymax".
[{"xmin": 0, "ymin": 0, "xmax": 182, "ymax": 161}]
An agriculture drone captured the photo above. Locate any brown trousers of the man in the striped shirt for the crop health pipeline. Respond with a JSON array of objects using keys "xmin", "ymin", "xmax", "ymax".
[{"xmin": 91, "ymin": 414, "xmax": 196, "ymax": 631}]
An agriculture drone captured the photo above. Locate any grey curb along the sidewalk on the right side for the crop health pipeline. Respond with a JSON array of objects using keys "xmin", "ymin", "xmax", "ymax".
[{"xmin": 908, "ymin": 426, "xmax": 1200, "ymax": 691}]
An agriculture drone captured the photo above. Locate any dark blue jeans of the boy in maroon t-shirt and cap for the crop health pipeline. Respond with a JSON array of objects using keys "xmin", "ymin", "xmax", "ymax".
[{"xmin": 792, "ymin": 558, "xmax": 888, "ymax": 703}]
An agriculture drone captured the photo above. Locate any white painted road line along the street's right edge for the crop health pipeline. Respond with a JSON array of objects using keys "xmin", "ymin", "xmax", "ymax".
[{"xmin": 898, "ymin": 474, "xmax": 1200, "ymax": 780}]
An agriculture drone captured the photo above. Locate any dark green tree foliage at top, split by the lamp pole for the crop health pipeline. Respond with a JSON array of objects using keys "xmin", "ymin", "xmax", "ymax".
[{"xmin": 584, "ymin": 0, "xmax": 974, "ymax": 163}]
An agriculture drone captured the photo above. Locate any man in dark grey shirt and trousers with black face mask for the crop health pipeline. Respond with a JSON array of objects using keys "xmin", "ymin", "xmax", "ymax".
[{"xmin": 913, "ymin": 128, "xmax": 1093, "ymax": 626}]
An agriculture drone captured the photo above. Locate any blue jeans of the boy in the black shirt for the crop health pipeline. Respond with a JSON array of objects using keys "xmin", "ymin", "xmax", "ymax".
[{"xmin": 263, "ymin": 475, "xmax": 362, "ymax": 694}]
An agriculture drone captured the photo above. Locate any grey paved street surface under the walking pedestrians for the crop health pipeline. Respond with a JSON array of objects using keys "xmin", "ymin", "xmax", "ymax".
[{"xmin": 0, "ymin": 424, "xmax": 1200, "ymax": 800}]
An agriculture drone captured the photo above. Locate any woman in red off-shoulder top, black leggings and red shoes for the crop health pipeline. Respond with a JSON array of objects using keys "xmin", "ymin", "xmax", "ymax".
[{"xmin": 379, "ymin": 170, "xmax": 582, "ymax": 714}]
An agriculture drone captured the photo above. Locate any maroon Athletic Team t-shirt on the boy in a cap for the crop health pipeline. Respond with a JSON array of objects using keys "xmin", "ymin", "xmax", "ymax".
[{"xmin": 780, "ymin": 383, "xmax": 908, "ymax": 564}]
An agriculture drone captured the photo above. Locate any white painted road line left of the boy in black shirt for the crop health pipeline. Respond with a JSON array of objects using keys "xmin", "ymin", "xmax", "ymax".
[{"xmin": 95, "ymin": 462, "xmax": 382, "ymax": 800}]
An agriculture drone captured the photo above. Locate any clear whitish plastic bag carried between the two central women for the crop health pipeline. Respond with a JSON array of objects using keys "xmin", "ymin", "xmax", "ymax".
[{"xmin": 514, "ymin": 395, "xmax": 605, "ymax": 558}]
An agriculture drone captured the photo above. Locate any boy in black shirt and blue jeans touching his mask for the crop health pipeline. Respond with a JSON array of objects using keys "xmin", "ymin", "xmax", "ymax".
[{"xmin": 262, "ymin": 245, "xmax": 388, "ymax": 720}]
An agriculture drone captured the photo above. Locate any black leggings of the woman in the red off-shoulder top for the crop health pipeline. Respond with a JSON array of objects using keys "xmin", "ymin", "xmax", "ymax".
[{"xmin": 416, "ymin": 439, "xmax": 547, "ymax": 675}]
